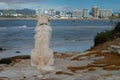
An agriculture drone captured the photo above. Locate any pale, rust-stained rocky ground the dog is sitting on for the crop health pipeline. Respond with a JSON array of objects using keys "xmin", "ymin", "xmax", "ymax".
[{"xmin": 0, "ymin": 50, "xmax": 120, "ymax": 80}]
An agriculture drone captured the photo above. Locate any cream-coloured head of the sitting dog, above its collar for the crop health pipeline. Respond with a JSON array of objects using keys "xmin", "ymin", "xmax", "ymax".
[{"xmin": 37, "ymin": 14, "xmax": 50, "ymax": 25}]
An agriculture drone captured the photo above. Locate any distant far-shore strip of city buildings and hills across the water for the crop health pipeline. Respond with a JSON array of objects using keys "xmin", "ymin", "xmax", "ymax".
[{"xmin": 0, "ymin": 6, "xmax": 114, "ymax": 19}]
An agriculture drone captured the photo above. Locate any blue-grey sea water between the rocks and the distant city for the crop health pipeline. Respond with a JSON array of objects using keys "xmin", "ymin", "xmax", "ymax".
[{"xmin": 0, "ymin": 20, "xmax": 114, "ymax": 58}]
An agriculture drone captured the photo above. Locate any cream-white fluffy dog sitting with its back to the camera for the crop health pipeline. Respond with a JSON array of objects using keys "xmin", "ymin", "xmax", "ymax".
[{"xmin": 31, "ymin": 14, "xmax": 54, "ymax": 72}]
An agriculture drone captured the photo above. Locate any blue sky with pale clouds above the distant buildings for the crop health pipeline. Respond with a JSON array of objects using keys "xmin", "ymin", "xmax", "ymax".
[{"xmin": 0, "ymin": 0, "xmax": 120, "ymax": 12}]
